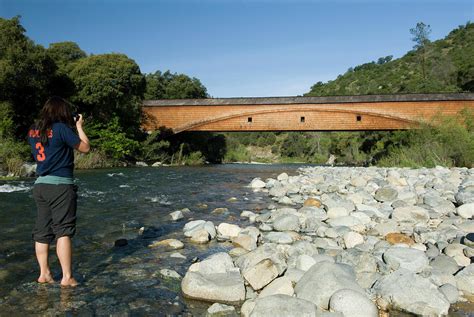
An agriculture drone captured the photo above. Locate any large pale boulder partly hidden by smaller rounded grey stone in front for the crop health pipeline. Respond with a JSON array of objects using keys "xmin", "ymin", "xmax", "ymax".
[{"xmin": 295, "ymin": 261, "xmax": 364, "ymax": 309}]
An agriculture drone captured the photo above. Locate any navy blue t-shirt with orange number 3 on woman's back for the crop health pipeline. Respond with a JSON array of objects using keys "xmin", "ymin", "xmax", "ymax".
[{"xmin": 28, "ymin": 122, "xmax": 81, "ymax": 178}]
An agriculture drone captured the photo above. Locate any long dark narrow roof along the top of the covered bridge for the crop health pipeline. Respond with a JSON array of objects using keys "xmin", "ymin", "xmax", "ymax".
[{"xmin": 143, "ymin": 93, "xmax": 474, "ymax": 107}]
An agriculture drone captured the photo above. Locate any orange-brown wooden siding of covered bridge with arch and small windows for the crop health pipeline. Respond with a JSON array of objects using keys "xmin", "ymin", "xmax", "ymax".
[{"xmin": 144, "ymin": 100, "xmax": 474, "ymax": 132}]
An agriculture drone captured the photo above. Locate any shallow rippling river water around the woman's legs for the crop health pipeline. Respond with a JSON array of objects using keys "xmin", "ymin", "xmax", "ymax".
[{"xmin": 0, "ymin": 165, "xmax": 299, "ymax": 316}]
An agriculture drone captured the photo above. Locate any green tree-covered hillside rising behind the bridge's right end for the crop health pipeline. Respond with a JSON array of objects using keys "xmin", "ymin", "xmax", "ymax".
[{"xmin": 305, "ymin": 22, "xmax": 474, "ymax": 96}]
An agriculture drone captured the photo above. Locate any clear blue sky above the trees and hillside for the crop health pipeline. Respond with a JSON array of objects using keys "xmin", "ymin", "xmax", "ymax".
[{"xmin": 0, "ymin": 0, "xmax": 474, "ymax": 97}]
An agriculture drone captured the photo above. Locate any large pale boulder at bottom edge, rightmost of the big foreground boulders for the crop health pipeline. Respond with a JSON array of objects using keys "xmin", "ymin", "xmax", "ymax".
[{"xmin": 372, "ymin": 269, "xmax": 449, "ymax": 316}]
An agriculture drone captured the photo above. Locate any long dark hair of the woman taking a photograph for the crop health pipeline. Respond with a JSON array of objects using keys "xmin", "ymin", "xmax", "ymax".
[{"xmin": 36, "ymin": 96, "xmax": 74, "ymax": 145}]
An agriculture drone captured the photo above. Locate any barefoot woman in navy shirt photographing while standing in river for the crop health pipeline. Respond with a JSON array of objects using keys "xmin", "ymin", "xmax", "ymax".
[{"xmin": 28, "ymin": 97, "xmax": 90, "ymax": 286}]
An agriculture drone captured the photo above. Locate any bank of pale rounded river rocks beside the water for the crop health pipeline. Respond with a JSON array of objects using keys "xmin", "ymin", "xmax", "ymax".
[{"xmin": 174, "ymin": 167, "xmax": 474, "ymax": 317}]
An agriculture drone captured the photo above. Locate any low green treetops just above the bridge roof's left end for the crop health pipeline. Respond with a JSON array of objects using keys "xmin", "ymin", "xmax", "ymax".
[{"xmin": 145, "ymin": 70, "xmax": 208, "ymax": 99}]
